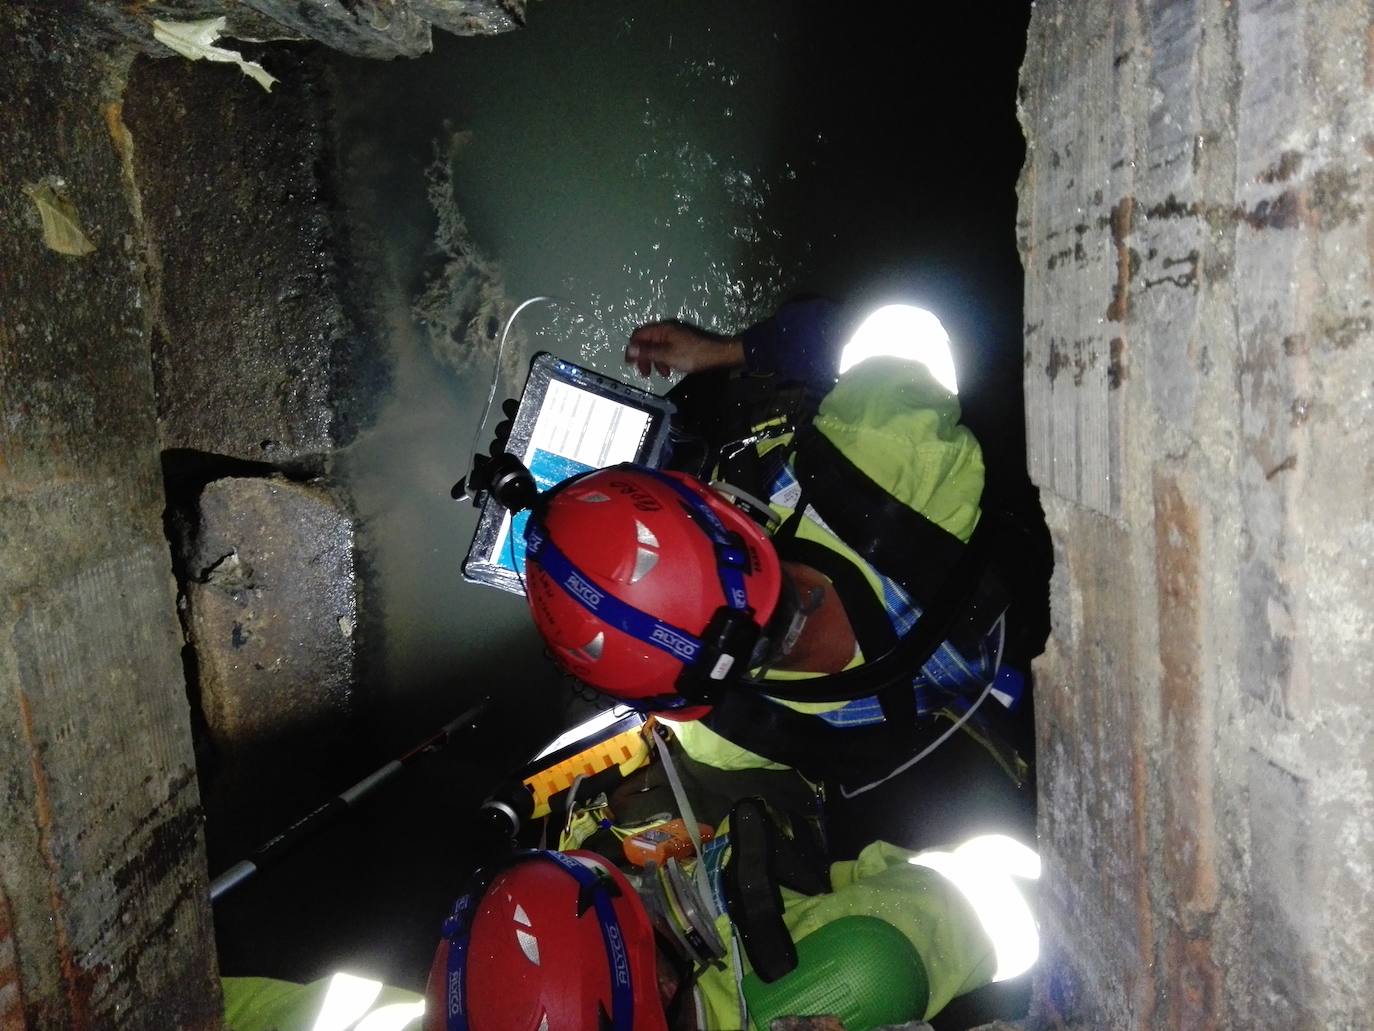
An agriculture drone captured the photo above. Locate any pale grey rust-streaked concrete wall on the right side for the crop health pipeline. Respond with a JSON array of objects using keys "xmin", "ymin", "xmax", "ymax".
[{"xmin": 1020, "ymin": 0, "xmax": 1374, "ymax": 1028}]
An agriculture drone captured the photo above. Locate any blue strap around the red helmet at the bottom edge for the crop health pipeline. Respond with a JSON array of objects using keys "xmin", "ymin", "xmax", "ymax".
[{"xmin": 444, "ymin": 852, "xmax": 635, "ymax": 1031}]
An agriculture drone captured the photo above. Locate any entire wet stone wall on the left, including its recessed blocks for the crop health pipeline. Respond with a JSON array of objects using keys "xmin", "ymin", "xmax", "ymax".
[{"xmin": 0, "ymin": 0, "xmax": 535, "ymax": 1030}]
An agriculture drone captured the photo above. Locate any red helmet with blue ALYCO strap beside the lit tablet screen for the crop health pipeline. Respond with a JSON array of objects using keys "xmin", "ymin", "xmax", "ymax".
[{"xmin": 525, "ymin": 465, "xmax": 782, "ymax": 719}]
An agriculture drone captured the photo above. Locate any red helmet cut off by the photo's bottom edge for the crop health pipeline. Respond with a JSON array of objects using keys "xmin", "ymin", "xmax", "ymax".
[{"xmin": 425, "ymin": 852, "xmax": 668, "ymax": 1031}]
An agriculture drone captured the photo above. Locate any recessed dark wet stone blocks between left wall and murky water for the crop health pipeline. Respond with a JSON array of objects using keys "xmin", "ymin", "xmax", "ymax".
[{"xmin": 113, "ymin": 45, "xmax": 390, "ymax": 873}]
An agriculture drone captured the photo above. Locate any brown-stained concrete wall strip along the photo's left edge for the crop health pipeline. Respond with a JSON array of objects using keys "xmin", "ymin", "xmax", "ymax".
[{"xmin": 0, "ymin": 5, "xmax": 218, "ymax": 1030}]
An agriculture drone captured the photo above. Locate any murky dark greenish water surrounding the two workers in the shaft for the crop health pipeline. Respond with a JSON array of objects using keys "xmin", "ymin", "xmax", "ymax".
[{"xmin": 216, "ymin": 0, "xmax": 1033, "ymax": 1027}]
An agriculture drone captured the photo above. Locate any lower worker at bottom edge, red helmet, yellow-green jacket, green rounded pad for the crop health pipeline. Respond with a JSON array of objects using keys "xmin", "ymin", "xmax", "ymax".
[{"xmin": 425, "ymin": 800, "xmax": 1039, "ymax": 1031}]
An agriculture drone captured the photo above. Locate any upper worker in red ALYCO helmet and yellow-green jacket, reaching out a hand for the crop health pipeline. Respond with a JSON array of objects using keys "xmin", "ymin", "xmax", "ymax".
[{"xmin": 526, "ymin": 301, "xmax": 1043, "ymax": 793}]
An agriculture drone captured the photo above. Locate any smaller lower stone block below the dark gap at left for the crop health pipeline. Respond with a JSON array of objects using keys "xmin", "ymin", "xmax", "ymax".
[{"xmin": 181, "ymin": 477, "xmax": 370, "ymax": 857}]
